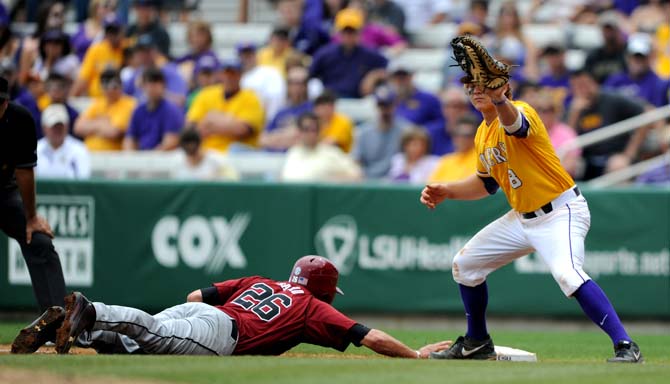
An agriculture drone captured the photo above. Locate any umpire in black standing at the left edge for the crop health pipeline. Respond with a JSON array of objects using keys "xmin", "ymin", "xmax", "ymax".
[{"xmin": 0, "ymin": 77, "xmax": 66, "ymax": 311}]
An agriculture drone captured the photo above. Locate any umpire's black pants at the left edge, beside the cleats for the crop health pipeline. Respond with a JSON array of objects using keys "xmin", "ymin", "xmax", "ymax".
[{"xmin": 0, "ymin": 189, "xmax": 66, "ymax": 311}]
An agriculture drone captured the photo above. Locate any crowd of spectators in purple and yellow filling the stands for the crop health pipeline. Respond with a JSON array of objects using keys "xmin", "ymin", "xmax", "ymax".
[{"xmin": 0, "ymin": 0, "xmax": 670, "ymax": 183}]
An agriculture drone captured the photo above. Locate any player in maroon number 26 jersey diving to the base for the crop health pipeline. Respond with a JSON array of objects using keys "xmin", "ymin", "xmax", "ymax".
[{"xmin": 12, "ymin": 256, "xmax": 451, "ymax": 359}]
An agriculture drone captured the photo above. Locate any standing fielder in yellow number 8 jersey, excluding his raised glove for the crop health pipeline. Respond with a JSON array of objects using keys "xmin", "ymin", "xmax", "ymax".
[{"xmin": 421, "ymin": 83, "xmax": 642, "ymax": 363}]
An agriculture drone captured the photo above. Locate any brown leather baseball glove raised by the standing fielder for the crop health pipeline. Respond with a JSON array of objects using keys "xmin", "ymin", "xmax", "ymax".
[{"xmin": 451, "ymin": 36, "xmax": 511, "ymax": 89}]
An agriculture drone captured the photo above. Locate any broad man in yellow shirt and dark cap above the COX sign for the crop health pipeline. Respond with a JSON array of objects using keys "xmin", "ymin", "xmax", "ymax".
[{"xmin": 186, "ymin": 61, "xmax": 265, "ymax": 151}]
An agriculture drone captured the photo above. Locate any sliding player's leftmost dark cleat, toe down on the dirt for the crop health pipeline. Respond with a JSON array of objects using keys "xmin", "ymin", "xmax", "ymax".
[{"xmin": 12, "ymin": 307, "xmax": 65, "ymax": 354}]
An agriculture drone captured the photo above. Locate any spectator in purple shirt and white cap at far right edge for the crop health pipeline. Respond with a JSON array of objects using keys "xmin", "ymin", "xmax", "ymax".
[{"xmin": 603, "ymin": 33, "xmax": 668, "ymax": 107}]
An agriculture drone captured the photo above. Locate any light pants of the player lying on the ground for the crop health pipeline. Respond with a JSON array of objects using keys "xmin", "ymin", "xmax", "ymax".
[{"xmin": 79, "ymin": 302, "xmax": 237, "ymax": 355}]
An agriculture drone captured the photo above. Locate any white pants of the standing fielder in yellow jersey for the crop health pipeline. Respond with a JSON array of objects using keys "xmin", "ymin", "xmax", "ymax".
[{"xmin": 452, "ymin": 190, "xmax": 591, "ymax": 296}]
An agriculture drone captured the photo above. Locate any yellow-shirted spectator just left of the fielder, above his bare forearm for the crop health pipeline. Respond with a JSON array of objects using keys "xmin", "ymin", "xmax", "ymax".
[{"xmin": 428, "ymin": 113, "xmax": 480, "ymax": 183}]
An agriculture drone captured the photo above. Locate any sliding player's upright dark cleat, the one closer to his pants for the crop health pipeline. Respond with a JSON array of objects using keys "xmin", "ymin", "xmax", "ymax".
[{"xmin": 56, "ymin": 292, "xmax": 95, "ymax": 354}]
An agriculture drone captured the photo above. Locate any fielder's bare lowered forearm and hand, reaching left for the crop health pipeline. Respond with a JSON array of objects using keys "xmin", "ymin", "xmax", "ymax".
[{"xmin": 420, "ymin": 174, "xmax": 489, "ymax": 209}]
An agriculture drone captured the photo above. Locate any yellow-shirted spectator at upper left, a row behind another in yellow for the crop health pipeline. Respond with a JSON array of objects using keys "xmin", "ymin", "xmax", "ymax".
[{"xmin": 72, "ymin": 14, "xmax": 123, "ymax": 97}]
